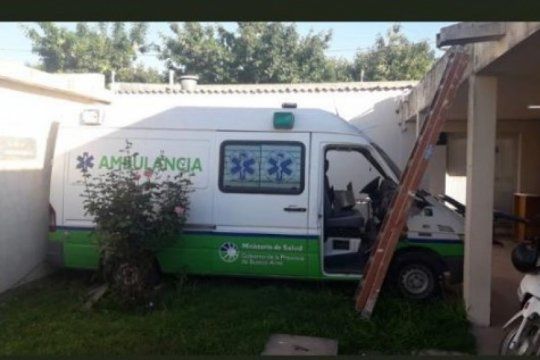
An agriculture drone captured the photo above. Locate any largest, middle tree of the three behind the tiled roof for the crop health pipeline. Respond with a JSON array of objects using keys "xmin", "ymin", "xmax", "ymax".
[{"xmin": 160, "ymin": 22, "xmax": 338, "ymax": 83}]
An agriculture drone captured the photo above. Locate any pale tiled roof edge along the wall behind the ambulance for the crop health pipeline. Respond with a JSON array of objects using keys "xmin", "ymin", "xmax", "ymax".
[{"xmin": 111, "ymin": 81, "xmax": 418, "ymax": 95}]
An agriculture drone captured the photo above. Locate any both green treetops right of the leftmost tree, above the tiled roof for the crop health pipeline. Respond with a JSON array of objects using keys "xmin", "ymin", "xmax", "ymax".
[{"xmin": 160, "ymin": 22, "xmax": 435, "ymax": 83}]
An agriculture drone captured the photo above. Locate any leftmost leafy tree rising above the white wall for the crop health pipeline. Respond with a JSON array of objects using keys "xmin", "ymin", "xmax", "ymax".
[{"xmin": 25, "ymin": 22, "xmax": 159, "ymax": 81}]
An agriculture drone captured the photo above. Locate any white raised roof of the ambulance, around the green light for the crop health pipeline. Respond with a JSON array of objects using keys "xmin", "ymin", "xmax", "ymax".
[{"xmin": 103, "ymin": 106, "xmax": 360, "ymax": 135}]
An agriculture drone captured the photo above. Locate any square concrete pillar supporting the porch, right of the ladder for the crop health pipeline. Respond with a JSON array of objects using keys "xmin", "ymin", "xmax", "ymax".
[{"xmin": 463, "ymin": 75, "xmax": 497, "ymax": 326}]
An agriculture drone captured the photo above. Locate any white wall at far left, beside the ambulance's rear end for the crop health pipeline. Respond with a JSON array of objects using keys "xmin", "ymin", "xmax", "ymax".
[{"xmin": 0, "ymin": 72, "xmax": 108, "ymax": 292}]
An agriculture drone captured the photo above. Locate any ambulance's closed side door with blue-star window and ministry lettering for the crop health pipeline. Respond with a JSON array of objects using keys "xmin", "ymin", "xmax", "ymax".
[{"xmin": 214, "ymin": 132, "xmax": 310, "ymax": 276}]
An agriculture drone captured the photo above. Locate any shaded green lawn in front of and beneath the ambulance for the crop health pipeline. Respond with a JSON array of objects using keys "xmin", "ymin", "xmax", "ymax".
[{"xmin": 0, "ymin": 272, "xmax": 475, "ymax": 357}]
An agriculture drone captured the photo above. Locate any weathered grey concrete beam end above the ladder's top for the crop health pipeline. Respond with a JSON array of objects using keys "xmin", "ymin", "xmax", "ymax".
[{"xmin": 437, "ymin": 22, "xmax": 506, "ymax": 48}]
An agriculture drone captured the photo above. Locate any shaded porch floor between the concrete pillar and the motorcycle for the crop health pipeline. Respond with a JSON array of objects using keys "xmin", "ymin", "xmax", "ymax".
[{"xmin": 473, "ymin": 237, "xmax": 523, "ymax": 355}]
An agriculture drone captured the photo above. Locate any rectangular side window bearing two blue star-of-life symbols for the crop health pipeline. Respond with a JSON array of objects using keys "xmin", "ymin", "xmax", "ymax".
[{"xmin": 219, "ymin": 141, "xmax": 305, "ymax": 194}]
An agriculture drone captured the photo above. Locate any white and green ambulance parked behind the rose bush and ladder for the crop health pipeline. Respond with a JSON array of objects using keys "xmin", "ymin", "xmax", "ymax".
[{"xmin": 49, "ymin": 106, "xmax": 464, "ymax": 299}]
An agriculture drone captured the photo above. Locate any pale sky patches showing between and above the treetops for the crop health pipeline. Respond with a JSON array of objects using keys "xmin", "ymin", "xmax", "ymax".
[{"xmin": 0, "ymin": 22, "xmax": 453, "ymax": 69}]
